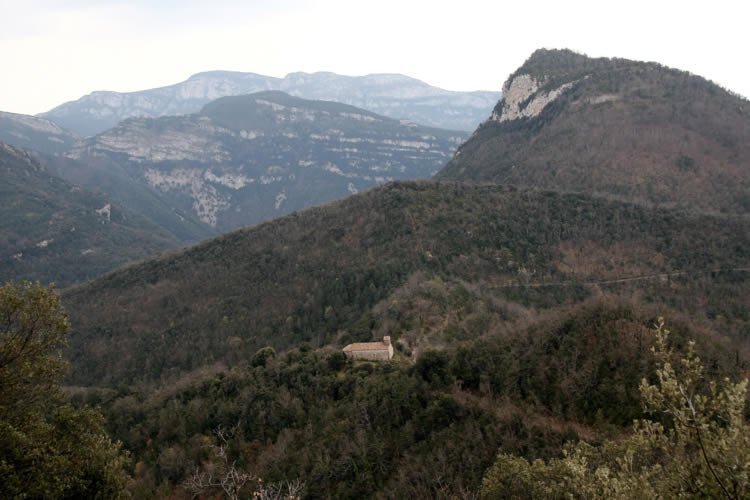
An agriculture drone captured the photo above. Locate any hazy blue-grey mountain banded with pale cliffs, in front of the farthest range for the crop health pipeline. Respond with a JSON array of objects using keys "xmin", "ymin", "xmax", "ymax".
[{"xmin": 67, "ymin": 91, "xmax": 466, "ymax": 231}]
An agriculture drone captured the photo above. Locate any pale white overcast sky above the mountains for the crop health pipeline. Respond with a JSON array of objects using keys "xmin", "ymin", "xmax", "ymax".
[{"xmin": 0, "ymin": 0, "xmax": 750, "ymax": 114}]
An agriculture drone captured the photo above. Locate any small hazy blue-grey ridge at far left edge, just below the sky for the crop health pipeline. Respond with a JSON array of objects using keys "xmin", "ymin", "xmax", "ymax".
[{"xmin": 0, "ymin": 111, "xmax": 78, "ymax": 154}]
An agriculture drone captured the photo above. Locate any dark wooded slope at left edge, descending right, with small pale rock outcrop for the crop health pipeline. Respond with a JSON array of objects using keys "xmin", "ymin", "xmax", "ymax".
[{"xmin": 0, "ymin": 143, "xmax": 180, "ymax": 286}]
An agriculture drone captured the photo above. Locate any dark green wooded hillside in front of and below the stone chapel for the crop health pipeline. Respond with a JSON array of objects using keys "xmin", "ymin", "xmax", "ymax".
[{"xmin": 71, "ymin": 298, "xmax": 748, "ymax": 498}]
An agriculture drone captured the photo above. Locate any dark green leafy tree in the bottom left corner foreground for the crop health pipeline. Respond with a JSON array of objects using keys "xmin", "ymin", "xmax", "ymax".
[{"xmin": 0, "ymin": 282, "xmax": 128, "ymax": 498}]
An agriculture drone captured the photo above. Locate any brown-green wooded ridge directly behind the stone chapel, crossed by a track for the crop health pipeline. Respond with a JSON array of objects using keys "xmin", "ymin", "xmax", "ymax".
[{"xmin": 64, "ymin": 182, "xmax": 750, "ymax": 385}]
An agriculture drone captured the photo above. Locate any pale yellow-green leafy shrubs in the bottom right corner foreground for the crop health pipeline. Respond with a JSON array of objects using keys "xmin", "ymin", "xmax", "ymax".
[{"xmin": 482, "ymin": 318, "xmax": 750, "ymax": 499}]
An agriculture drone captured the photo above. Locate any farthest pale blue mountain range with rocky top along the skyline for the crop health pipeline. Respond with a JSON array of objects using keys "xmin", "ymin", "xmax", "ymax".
[{"xmin": 40, "ymin": 71, "xmax": 500, "ymax": 136}]
